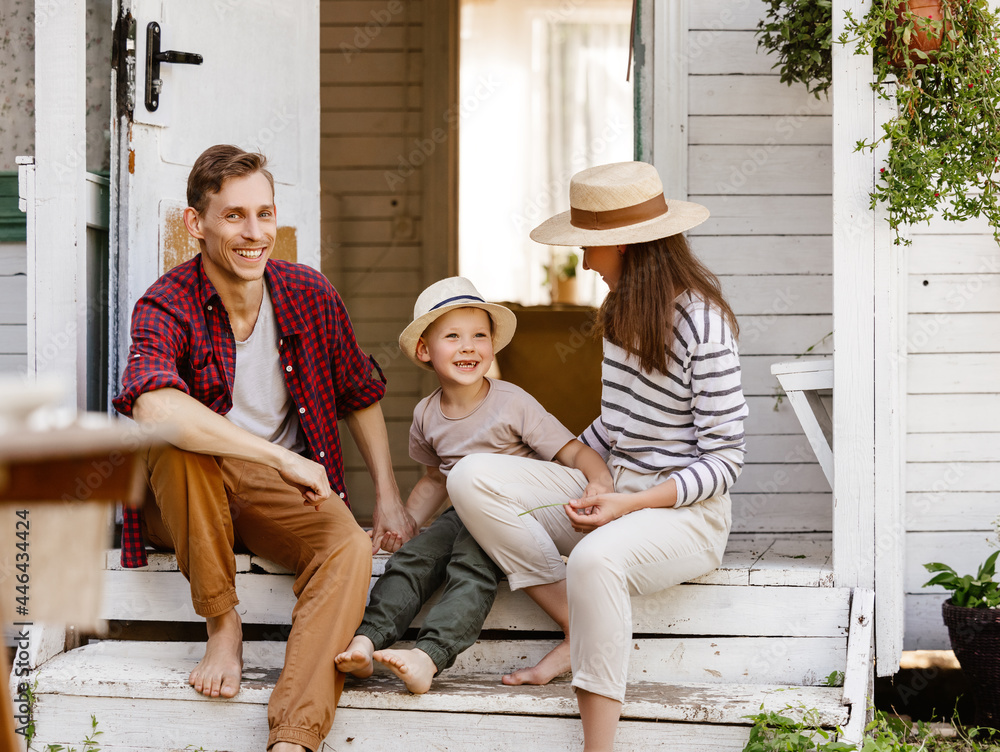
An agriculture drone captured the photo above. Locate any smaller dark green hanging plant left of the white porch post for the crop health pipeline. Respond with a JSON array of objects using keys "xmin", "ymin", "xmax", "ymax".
[{"xmin": 757, "ymin": 0, "xmax": 833, "ymax": 99}]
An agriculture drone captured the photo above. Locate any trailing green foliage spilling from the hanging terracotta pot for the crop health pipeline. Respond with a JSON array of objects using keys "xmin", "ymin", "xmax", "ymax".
[{"xmin": 838, "ymin": 0, "xmax": 1000, "ymax": 245}]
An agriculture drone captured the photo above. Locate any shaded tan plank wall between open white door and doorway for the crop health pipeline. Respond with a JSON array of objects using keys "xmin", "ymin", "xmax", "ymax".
[{"xmin": 320, "ymin": 0, "xmax": 430, "ymax": 517}]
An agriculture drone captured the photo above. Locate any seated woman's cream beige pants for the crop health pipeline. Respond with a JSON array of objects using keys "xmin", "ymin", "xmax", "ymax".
[{"xmin": 448, "ymin": 454, "xmax": 731, "ymax": 702}]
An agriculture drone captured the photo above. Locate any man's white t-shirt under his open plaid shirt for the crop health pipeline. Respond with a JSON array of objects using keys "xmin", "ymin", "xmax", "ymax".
[{"xmin": 226, "ymin": 284, "xmax": 305, "ymax": 453}]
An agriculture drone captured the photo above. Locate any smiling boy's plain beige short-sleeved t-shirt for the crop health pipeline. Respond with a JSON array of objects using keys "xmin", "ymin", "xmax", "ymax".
[{"xmin": 410, "ymin": 379, "xmax": 576, "ymax": 475}]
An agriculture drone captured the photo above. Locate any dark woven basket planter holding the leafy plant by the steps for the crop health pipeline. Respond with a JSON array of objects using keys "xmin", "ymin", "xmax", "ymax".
[{"xmin": 942, "ymin": 600, "xmax": 1000, "ymax": 728}]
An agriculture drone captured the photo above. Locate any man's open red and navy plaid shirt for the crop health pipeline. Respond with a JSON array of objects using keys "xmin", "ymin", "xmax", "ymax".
[{"xmin": 114, "ymin": 255, "xmax": 385, "ymax": 567}]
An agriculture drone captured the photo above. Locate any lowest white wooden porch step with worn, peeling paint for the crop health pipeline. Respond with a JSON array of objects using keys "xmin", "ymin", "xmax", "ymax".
[{"xmin": 27, "ymin": 642, "xmax": 848, "ymax": 752}]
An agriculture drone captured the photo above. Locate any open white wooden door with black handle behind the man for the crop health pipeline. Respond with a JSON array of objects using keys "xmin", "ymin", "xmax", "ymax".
[{"xmin": 109, "ymin": 0, "xmax": 320, "ymax": 392}]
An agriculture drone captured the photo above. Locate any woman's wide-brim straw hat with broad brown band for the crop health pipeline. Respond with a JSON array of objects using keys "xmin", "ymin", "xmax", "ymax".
[{"xmin": 531, "ymin": 162, "xmax": 709, "ymax": 246}]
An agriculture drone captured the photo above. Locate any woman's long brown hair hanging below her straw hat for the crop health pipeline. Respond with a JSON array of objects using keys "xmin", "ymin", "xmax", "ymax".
[{"xmin": 597, "ymin": 235, "xmax": 739, "ymax": 373}]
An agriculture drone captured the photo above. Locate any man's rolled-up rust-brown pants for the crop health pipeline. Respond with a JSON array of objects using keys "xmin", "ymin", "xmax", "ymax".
[{"xmin": 143, "ymin": 446, "xmax": 371, "ymax": 750}]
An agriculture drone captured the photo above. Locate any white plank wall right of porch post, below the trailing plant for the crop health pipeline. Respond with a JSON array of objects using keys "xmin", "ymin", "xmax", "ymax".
[{"xmin": 904, "ymin": 220, "xmax": 1000, "ymax": 649}]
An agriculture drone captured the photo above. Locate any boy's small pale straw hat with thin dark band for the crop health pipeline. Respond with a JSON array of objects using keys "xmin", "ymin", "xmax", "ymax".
[{"xmin": 399, "ymin": 277, "xmax": 517, "ymax": 371}]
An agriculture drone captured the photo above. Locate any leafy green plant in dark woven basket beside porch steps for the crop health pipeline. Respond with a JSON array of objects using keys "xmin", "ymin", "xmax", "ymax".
[{"xmin": 924, "ymin": 518, "xmax": 1000, "ymax": 728}]
